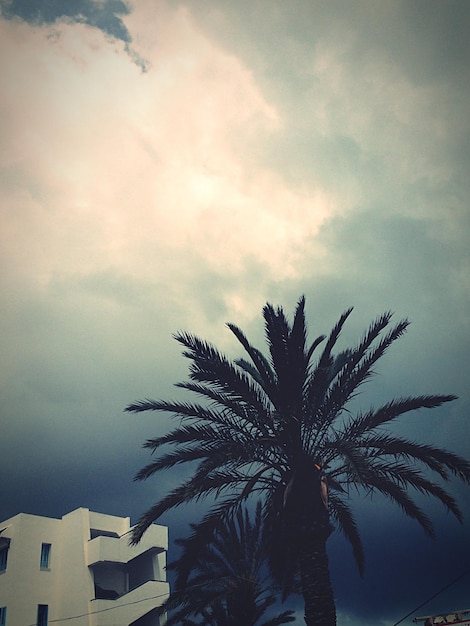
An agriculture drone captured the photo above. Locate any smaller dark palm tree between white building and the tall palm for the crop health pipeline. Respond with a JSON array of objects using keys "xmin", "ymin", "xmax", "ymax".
[{"xmin": 159, "ymin": 503, "xmax": 295, "ymax": 626}]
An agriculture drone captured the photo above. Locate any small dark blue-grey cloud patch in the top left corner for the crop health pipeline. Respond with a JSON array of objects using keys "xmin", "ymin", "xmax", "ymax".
[{"xmin": 0, "ymin": 0, "xmax": 131, "ymax": 43}]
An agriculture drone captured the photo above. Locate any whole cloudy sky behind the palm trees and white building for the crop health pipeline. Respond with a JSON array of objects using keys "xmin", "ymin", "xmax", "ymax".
[{"xmin": 0, "ymin": 0, "xmax": 470, "ymax": 626}]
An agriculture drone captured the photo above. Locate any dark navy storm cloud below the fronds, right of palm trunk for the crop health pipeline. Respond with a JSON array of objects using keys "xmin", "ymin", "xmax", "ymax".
[{"xmin": 329, "ymin": 501, "xmax": 470, "ymax": 624}]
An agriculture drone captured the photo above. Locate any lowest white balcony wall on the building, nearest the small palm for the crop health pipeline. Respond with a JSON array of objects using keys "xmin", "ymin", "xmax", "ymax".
[{"xmin": 90, "ymin": 580, "xmax": 169, "ymax": 626}]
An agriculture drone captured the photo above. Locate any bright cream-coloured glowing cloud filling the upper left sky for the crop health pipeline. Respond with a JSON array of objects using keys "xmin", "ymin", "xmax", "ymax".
[{"xmin": 2, "ymin": 2, "xmax": 342, "ymax": 330}]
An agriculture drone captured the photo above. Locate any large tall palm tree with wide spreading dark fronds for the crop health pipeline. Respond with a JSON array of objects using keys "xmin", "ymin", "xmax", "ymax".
[{"xmin": 127, "ymin": 297, "xmax": 470, "ymax": 626}]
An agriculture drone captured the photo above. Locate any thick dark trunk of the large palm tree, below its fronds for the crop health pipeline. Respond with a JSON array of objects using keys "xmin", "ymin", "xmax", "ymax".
[{"xmin": 299, "ymin": 530, "xmax": 336, "ymax": 626}]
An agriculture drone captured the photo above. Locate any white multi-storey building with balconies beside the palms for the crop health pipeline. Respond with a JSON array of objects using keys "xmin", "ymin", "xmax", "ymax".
[{"xmin": 0, "ymin": 508, "xmax": 169, "ymax": 626}]
